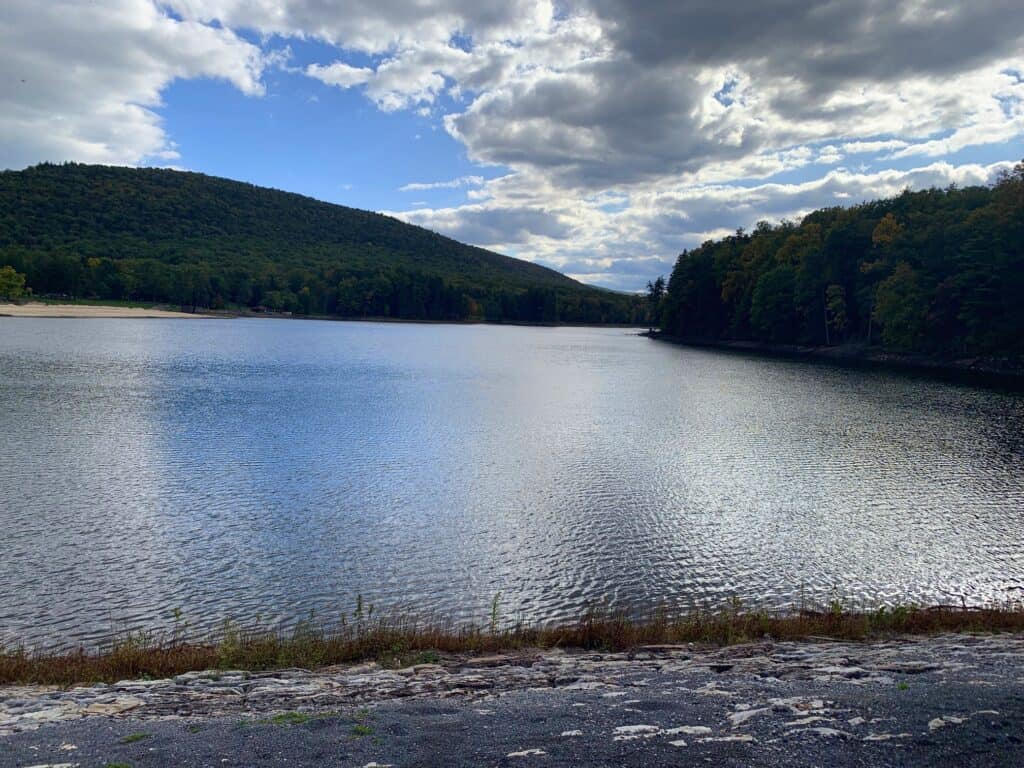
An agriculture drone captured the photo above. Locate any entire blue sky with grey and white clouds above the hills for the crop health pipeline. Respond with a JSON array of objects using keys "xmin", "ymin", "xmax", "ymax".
[{"xmin": 0, "ymin": 0, "xmax": 1024, "ymax": 290}]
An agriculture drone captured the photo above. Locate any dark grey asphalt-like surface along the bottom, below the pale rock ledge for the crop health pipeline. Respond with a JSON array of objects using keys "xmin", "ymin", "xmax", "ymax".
[{"xmin": 0, "ymin": 659, "xmax": 1024, "ymax": 768}]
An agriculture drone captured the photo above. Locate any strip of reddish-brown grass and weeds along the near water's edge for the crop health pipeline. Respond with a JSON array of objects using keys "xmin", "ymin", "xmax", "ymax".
[{"xmin": 0, "ymin": 598, "xmax": 1024, "ymax": 686}]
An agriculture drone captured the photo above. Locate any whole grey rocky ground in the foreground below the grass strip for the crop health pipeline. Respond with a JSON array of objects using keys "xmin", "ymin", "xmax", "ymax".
[{"xmin": 0, "ymin": 635, "xmax": 1024, "ymax": 768}]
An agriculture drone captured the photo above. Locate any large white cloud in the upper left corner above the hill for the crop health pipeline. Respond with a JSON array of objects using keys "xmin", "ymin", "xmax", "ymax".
[{"xmin": 0, "ymin": 0, "xmax": 264, "ymax": 168}]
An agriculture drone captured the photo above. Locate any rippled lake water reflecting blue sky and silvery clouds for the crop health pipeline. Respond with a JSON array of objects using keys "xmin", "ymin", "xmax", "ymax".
[{"xmin": 0, "ymin": 318, "xmax": 1024, "ymax": 647}]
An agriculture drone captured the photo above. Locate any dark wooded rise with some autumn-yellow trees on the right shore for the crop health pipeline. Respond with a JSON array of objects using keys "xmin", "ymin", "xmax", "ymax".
[{"xmin": 659, "ymin": 163, "xmax": 1024, "ymax": 360}]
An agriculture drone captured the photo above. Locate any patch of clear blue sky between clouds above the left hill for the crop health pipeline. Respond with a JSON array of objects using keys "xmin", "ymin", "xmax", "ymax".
[{"xmin": 155, "ymin": 32, "xmax": 495, "ymax": 211}]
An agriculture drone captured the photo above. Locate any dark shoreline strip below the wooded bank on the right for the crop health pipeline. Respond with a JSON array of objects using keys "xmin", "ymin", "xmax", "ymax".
[{"xmin": 640, "ymin": 331, "xmax": 1024, "ymax": 389}]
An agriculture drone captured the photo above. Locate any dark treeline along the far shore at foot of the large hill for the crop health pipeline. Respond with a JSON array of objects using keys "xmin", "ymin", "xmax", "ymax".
[{"xmin": 0, "ymin": 249, "xmax": 642, "ymax": 324}]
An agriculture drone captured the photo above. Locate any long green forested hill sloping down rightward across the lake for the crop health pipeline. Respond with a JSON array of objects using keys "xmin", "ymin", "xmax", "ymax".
[{"xmin": 0, "ymin": 164, "xmax": 641, "ymax": 323}]
